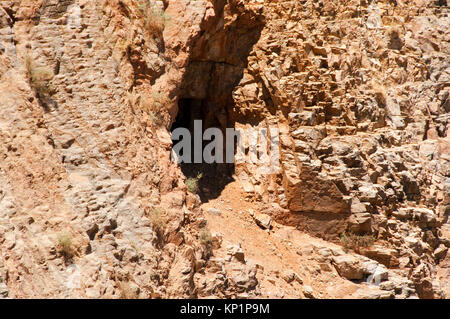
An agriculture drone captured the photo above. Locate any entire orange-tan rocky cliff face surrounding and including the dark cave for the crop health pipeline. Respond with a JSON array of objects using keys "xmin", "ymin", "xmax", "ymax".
[{"xmin": 0, "ymin": 0, "xmax": 450, "ymax": 298}]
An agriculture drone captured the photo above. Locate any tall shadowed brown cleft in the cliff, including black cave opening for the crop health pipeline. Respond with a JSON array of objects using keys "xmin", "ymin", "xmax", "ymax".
[{"xmin": 172, "ymin": 1, "xmax": 265, "ymax": 202}]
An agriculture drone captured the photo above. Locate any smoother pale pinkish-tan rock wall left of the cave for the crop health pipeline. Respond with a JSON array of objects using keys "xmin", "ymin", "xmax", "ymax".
[{"xmin": 0, "ymin": 1, "xmax": 213, "ymax": 298}]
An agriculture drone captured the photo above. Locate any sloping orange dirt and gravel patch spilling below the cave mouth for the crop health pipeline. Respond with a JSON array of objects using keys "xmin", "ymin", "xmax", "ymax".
[{"xmin": 202, "ymin": 181, "xmax": 359, "ymax": 298}]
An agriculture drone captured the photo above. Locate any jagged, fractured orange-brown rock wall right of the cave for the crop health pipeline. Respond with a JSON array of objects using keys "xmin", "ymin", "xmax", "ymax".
[{"xmin": 233, "ymin": 1, "xmax": 450, "ymax": 296}]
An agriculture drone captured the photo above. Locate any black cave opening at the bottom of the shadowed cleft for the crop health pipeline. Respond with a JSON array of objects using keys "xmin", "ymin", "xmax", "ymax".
[{"xmin": 171, "ymin": 98, "xmax": 234, "ymax": 202}]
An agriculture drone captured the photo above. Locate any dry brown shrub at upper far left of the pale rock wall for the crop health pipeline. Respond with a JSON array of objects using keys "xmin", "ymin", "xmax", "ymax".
[{"xmin": 25, "ymin": 55, "xmax": 54, "ymax": 98}]
